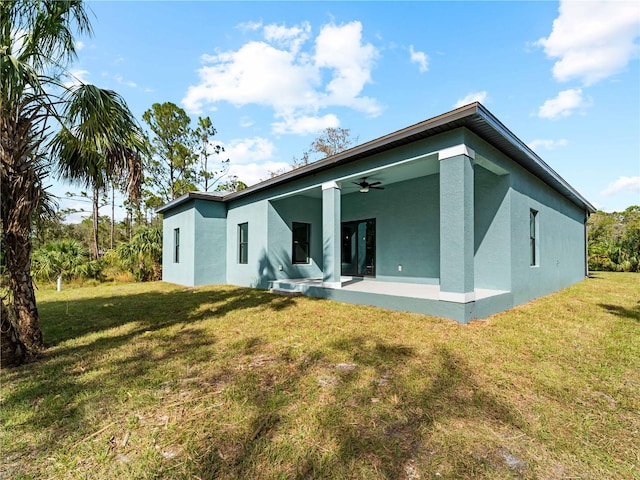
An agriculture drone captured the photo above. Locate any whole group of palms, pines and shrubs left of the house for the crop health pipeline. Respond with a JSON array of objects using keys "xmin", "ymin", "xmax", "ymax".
[{"xmin": 0, "ymin": 0, "xmax": 360, "ymax": 365}]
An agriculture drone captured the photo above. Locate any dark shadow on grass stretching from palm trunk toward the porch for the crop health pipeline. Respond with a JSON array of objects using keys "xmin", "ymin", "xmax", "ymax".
[{"xmin": 1, "ymin": 287, "xmax": 295, "ymax": 468}]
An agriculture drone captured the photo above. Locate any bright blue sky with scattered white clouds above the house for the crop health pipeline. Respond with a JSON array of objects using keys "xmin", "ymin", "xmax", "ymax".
[{"xmin": 52, "ymin": 1, "xmax": 640, "ymax": 221}]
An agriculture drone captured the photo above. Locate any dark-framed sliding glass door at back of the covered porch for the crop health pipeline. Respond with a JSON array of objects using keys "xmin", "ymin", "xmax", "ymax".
[{"xmin": 342, "ymin": 218, "xmax": 376, "ymax": 277}]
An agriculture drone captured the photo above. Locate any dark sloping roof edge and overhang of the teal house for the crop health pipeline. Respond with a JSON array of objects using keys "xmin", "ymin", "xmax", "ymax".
[{"xmin": 157, "ymin": 102, "xmax": 596, "ymax": 213}]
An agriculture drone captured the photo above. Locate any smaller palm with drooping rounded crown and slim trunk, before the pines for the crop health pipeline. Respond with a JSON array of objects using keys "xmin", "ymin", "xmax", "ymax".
[{"xmin": 51, "ymin": 85, "xmax": 146, "ymax": 259}]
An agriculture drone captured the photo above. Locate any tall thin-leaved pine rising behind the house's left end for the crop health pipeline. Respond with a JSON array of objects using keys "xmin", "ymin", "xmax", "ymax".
[{"xmin": 142, "ymin": 102, "xmax": 197, "ymax": 203}]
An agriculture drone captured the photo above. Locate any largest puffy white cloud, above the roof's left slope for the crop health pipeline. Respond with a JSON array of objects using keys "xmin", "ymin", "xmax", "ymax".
[{"xmin": 182, "ymin": 22, "xmax": 381, "ymax": 129}]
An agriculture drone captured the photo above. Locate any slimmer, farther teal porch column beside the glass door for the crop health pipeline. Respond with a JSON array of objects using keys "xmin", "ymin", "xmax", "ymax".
[{"xmin": 322, "ymin": 182, "xmax": 342, "ymax": 288}]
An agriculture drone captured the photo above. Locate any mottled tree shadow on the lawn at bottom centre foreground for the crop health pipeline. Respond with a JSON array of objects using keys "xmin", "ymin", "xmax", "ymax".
[{"xmin": 190, "ymin": 335, "xmax": 526, "ymax": 480}]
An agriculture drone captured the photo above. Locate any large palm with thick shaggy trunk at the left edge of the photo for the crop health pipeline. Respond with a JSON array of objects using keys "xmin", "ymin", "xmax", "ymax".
[{"xmin": 0, "ymin": 0, "xmax": 141, "ymax": 362}]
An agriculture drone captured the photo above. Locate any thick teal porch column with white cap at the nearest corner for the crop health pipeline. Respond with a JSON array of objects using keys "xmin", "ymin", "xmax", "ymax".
[{"xmin": 438, "ymin": 145, "xmax": 475, "ymax": 303}]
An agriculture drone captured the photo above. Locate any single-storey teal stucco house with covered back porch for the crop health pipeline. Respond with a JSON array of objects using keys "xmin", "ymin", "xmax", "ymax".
[{"xmin": 158, "ymin": 103, "xmax": 595, "ymax": 322}]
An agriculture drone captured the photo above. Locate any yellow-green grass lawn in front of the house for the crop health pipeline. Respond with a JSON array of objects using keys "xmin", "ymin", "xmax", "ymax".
[{"xmin": 0, "ymin": 273, "xmax": 640, "ymax": 479}]
